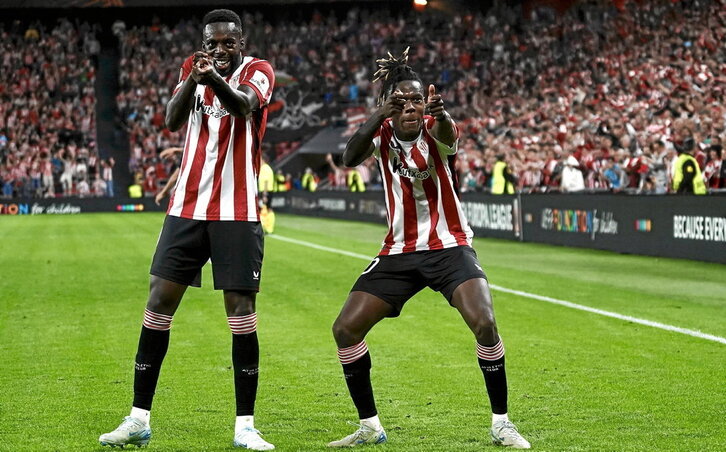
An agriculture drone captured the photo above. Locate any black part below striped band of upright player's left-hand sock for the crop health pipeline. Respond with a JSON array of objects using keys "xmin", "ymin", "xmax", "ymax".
[{"xmin": 133, "ymin": 326, "xmax": 169, "ymax": 410}]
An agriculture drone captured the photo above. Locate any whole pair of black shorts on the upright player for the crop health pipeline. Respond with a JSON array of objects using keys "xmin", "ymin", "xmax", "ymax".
[{"xmin": 150, "ymin": 215, "xmax": 264, "ymax": 292}]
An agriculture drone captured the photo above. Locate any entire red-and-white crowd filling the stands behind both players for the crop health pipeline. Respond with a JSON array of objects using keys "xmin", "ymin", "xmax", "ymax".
[{"xmin": 0, "ymin": 0, "xmax": 726, "ymax": 195}]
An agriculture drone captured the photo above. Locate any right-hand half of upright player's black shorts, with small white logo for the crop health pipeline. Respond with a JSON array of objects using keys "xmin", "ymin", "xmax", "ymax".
[{"xmin": 208, "ymin": 221, "xmax": 265, "ymax": 292}]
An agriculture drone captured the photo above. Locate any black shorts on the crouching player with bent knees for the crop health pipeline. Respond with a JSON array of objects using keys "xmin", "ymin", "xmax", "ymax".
[{"xmin": 351, "ymin": 246, "xmax": 486, "ymax": 317}]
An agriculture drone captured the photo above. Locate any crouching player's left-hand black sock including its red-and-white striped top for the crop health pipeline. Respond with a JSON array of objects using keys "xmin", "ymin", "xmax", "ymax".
[{"xmin": 338, "ymin": 341, "xmax": 378, "ymax": 419}]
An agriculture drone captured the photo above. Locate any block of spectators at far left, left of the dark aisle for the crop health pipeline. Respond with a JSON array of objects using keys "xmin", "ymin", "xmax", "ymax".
[{"xmin": 0, "ymin": 19, "xmax": 113, "ymax": 198}]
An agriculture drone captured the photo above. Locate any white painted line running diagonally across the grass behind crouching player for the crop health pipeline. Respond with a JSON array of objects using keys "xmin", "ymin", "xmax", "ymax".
[{"xmin": 266, "ymin": 235, "xmax": 726, "ymax": 344}]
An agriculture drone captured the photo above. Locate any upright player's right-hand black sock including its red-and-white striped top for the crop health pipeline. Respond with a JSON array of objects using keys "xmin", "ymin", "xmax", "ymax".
[{"xmin": 227, "ymin": 312, "xmax": 260, "ymax": 417}]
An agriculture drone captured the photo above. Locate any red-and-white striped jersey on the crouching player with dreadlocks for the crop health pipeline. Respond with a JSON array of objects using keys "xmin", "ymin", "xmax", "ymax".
[{"xmin": 373, "ymin": 116, "xmax": 474, "ymax": 256}]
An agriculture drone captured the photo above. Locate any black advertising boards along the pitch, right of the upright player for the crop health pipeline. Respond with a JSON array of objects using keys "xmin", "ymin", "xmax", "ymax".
[{"xmin": 272, "ymin": 191, "xmax": 726, "ymax": 263}]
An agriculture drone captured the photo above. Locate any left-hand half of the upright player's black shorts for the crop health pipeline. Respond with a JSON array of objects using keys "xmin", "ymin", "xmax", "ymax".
[{"xmin": 150, "ymin": 215, "xmax": 210, "ymax": 286}]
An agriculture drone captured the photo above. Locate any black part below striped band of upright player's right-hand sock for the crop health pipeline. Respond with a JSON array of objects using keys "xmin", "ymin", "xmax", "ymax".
[{"xmin": 232, "ymin": 331, "xmax": 260, "ymax": 416}]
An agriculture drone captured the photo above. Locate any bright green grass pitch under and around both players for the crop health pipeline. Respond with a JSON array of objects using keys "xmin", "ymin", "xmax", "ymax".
[{"xmin": 0, "ymin": 214, "xmax": 726, "ymax": 451}]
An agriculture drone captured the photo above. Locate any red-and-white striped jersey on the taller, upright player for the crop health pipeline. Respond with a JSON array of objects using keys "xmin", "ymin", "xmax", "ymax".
[{"xmin": 167, "ymin": 56, "xmax": 275, "ymax": 221}]
